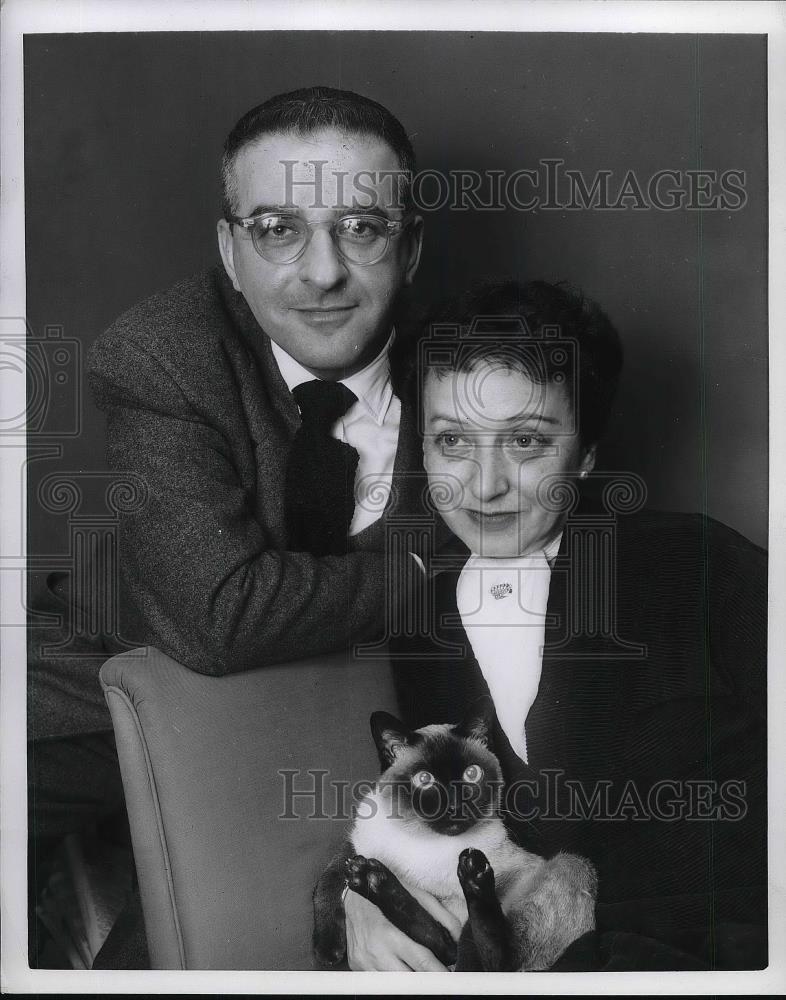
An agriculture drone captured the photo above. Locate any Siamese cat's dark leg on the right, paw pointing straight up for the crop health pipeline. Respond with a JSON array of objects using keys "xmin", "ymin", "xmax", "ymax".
[{"xmin": 457, "ymin": 848, "xmax": 513, "ymax": 972}]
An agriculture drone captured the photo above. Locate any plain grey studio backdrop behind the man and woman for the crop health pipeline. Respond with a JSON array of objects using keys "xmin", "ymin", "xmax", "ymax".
[{"xmin": 25, "ymin": 32, "xmax": 767, "ymax": 575}]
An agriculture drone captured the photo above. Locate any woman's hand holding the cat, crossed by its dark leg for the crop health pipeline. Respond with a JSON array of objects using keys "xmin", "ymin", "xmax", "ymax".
[{"xmin": 344, "ymin": 886, "xmax": 461, "ymax": 972}]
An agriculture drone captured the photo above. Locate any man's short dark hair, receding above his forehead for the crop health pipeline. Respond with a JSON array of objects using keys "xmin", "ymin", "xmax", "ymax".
[{"xmin": 221, "ymin": 87, "xmax": 415, "ymax": 219}]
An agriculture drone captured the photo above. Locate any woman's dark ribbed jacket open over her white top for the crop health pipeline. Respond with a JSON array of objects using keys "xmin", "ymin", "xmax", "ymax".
[{"xmin": 396, "ymin": 510, "xmax": 767, "ymax": 968}]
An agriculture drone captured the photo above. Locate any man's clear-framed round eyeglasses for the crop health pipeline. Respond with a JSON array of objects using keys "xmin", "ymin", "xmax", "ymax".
[{"xmin": 227, "ymin": 212, "xmax": 412, "ymax": 266}]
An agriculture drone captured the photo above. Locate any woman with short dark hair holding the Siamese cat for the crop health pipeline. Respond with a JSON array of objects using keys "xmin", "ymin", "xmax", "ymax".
[{"xmin": 345, "ymin": 282, "xmax": 767, "ymax": 970}]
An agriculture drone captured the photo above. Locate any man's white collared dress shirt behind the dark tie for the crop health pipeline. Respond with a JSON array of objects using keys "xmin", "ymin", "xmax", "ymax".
[{"xmin": 271, "ymin": 333, "xmax": 401, "ymax": 535}]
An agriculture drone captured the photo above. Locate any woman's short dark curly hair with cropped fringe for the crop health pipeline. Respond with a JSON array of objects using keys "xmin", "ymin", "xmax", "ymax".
[{"xmin": 408, "ymin": 281, "xmax": 622, "ymax": 447}]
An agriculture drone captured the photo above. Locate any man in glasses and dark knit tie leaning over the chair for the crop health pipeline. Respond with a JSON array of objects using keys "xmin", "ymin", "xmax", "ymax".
[{"xmin": 31, "ymin": 87, "xmax": 438, "ymax": 966}]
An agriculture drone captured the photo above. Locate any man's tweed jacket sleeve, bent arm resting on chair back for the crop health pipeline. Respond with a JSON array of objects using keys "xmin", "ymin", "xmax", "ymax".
[{"xmin": 89, "ymin": 338, "xmax": 385, "ymax": 675}]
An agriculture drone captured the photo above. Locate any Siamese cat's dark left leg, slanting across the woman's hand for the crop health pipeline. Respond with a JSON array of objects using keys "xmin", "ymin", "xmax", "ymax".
[{"xmin": 346, "ymin": 854, "xmax": 456, "ymax": 965}]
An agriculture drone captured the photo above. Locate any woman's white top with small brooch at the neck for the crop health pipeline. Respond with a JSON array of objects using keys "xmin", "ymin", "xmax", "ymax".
[{"xmin": 456, "ymin": 533, "xmax": 562, "ymax": 761}]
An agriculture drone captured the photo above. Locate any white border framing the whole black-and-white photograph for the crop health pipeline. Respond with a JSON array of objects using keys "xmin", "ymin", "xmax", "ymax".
[{"xmin": 0, "ymin": 0, "xmax": 786, "ymax": 995}]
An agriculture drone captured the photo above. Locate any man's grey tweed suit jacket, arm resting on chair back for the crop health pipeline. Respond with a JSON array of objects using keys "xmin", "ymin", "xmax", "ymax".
[{"xmin": 30, "ymin": 267, "xmax": 428, "ymax": 736}]
